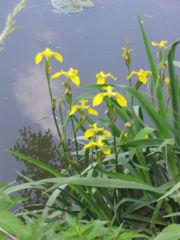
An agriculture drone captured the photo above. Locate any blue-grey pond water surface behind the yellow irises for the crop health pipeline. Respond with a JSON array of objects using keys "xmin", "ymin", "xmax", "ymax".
[{"xmin": 0, "ymin": 0, "xmax": 180, "ymax": 181}]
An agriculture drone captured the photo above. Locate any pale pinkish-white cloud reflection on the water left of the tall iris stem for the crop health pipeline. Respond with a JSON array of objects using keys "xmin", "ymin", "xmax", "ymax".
[{"xmin": 14, "ymin": 65, "xmax": 57, "ymax": 136}]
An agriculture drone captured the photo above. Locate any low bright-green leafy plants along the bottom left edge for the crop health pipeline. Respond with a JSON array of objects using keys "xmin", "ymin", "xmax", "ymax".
[{"xmin": 0, "ymin": 186, "xmax": 144, "ymax": 240}]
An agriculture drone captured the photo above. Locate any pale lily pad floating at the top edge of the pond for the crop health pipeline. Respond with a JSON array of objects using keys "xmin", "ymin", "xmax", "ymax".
[{"xmin": 51, "ymin": 0, "xmax": 93, "ymax": 14}]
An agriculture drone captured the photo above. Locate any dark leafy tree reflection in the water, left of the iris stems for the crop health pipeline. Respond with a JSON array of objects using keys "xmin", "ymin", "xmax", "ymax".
[{"xmin": 11, "ymin": 126, "xmax": 63, "ymax": 206}]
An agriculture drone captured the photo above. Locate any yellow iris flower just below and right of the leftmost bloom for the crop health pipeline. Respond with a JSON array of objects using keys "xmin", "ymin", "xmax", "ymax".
[{"xmin": 51, "ymin": 68, "xmax": 80, "ymax": 87}]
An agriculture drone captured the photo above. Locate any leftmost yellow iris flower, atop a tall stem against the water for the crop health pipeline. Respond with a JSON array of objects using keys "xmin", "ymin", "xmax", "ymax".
[{"xmin": 35, "ymin": 48, "xmax": 63, "ymax": 65}]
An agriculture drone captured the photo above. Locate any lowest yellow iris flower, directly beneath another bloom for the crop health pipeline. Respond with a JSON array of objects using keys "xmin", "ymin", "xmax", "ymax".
[{"xmin": 84, "ymin": 136, "xmax": 111, "ymax": 155}]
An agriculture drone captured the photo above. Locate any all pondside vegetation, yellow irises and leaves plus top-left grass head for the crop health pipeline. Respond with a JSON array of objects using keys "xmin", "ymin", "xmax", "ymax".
[{"xmin": 0, "ymin": 0, "xmax": 180, "ymax": 240}]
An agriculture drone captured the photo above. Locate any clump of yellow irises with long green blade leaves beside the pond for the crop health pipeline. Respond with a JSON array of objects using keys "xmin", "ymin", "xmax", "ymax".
[{"xmin": 5, "ymin": 15, "xmax": 180, "ymax": 240}]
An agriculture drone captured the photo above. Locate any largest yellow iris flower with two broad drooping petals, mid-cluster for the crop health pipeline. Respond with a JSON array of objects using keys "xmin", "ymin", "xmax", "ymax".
[{"xmin": 93, "ymin": 86, "xmax": 127, "ymax": 107}]
